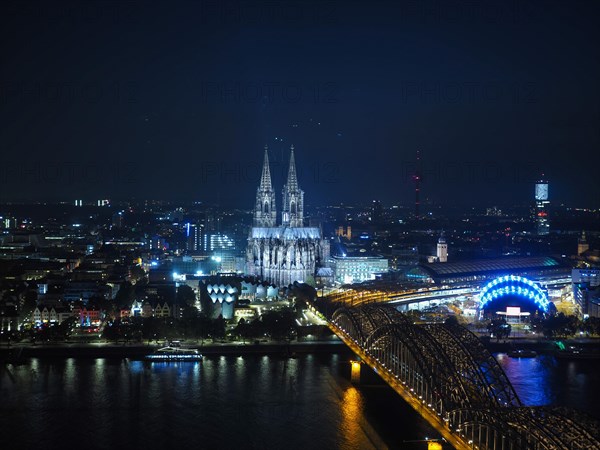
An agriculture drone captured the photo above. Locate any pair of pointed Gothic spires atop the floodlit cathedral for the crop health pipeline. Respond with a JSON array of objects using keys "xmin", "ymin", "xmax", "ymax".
[{"xmin": 254, "ymin": 145, "xmax": 304, "ymax": 228}]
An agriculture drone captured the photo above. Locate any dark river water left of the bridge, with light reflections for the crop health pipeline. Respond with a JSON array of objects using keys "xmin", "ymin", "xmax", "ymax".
[{"xmin": 0, "ymin": 354, "xmax": 440, "ymax": 450}]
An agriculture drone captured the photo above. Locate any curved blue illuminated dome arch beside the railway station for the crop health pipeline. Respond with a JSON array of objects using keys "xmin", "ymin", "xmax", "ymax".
[{"xmin": 479, "ymin": 275, "xmax": 550, "ymax": 312}]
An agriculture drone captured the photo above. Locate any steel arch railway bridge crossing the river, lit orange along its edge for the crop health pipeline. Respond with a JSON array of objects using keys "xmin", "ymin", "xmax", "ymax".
[{"xmin": 330, "ymin": 304, "xmax": 600, "ymax": 450}]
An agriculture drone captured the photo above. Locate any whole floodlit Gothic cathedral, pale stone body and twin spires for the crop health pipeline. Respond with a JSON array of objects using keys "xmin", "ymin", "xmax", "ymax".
[{"xmin": 246, "ymin": 146, "xmax": 329, "ymax": 286}]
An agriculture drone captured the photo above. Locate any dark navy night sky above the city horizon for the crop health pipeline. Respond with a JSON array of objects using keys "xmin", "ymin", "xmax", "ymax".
[{"xmin": 0, "ymin": 0, "xmax": 600, "ymax": 208}]
